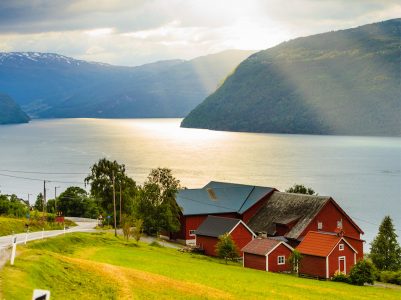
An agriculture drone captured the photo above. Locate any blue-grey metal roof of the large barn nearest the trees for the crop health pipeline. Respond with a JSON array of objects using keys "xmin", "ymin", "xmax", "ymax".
[{"xmin": 176, "ymin": 181, "xmax": 274, "ymax": 216}]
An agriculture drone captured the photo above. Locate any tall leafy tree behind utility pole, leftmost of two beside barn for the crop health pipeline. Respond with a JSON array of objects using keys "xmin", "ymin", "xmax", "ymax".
[{"xmin": 85, "ymin": 158, "xmax": 137, "ymax": 217}]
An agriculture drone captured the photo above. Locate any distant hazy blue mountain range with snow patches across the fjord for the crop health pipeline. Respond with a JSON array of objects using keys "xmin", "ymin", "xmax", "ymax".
[{"xmin": 0, "ymin": 50, "xmax": 254, "ymax": 118}]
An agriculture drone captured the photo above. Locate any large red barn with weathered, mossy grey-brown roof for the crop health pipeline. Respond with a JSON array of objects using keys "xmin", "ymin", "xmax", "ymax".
[{"xmin": 247, "ymin": 191, "xmax": 364, "ymax": 260}]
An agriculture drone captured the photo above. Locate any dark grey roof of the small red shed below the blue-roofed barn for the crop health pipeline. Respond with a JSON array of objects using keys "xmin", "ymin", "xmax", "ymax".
[{"xmin": 195, "ymin": 216, "xmax": 241, "ymax": 237}]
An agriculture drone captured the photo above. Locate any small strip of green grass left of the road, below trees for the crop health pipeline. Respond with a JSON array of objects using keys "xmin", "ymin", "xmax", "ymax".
[{"xmin": 0, "ymin": 217, "xmax": 75, "ymax": 236}]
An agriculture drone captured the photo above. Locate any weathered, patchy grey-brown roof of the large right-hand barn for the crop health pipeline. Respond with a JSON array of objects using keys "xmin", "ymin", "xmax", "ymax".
[{"xmin": 248, "ymin": 191, "xmax": 331, "ymax": 239}]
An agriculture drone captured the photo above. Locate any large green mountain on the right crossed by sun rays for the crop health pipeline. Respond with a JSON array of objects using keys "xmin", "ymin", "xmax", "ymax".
[{"xmin": 181, "ymin": 19, "xmax": 401, "ymax": 136}]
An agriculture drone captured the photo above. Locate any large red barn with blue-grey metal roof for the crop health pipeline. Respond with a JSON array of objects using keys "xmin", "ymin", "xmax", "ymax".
[{"xmin": 169, "ymin": 181, "xmax": 275, "ymax": 244}]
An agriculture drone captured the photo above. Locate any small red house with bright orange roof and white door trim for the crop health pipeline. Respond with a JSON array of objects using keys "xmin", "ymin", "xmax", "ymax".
[{"xmin": 296, "ymin": 231, "xmax": 358, "ymax": 278}]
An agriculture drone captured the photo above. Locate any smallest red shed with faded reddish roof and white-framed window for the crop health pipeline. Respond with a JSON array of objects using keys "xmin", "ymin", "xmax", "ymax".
[{"xmin": 242, "ymin": 238, "xmax": 294, "ymax": 272}]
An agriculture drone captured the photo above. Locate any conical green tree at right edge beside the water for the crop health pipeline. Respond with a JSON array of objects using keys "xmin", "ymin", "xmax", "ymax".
[{"xmin": 370, "ymin": 216, "xmax": 401, "ymax": 271}]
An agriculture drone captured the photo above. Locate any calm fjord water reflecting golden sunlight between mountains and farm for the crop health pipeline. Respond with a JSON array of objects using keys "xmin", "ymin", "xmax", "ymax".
[{"xmin": 0, "ymin": 119, "xmax": 401, "ymax": 247}]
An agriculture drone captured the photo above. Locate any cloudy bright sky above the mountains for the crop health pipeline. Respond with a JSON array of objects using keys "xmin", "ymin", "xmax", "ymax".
[{"xmin": 0, "ymin": 0, "xmax": 401, "ymax": 66}]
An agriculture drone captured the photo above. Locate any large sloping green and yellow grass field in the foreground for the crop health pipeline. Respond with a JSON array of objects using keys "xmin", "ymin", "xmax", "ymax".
[{"xmin": 0, "ymin": 233, "xmax": 401, "ymax": 300}]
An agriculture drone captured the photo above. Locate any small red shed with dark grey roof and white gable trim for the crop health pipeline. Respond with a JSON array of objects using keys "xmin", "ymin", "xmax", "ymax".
[{"xmin": 195, "ymin": 216, "xmax": 255, "ymax": 256}]
